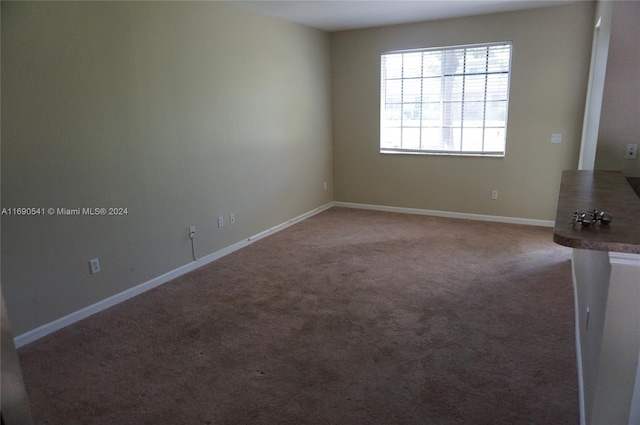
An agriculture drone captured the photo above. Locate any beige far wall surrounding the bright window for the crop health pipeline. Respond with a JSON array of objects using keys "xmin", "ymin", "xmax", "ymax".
[{"xmin": 331, "ymin": 2, "xmax": 595, "ymax": 220}]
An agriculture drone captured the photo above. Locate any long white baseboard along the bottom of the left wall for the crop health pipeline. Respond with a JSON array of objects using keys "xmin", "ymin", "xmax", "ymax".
[{"xmin": 14, "ymin": 202, "xmax": 334, "ymax": 348}]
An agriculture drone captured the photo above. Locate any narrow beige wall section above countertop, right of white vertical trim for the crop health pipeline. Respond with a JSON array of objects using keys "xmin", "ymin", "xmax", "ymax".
[{"xmin": 595, "ymin": 1, "xmax": 640, "ymax": 177}]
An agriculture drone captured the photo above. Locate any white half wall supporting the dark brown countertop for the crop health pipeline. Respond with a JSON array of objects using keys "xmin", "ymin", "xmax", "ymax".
[{"xmin": 573, "ymin": 249, "xmax": 640, "ymax": 425}]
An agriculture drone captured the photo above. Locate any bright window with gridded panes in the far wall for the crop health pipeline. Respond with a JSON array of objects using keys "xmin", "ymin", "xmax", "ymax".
[{"xmin": 380, "ymin": 42, "xmax": 511, "ymax": 156}]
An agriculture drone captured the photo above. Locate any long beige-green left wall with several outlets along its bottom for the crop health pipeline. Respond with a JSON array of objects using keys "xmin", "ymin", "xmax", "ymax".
[{"xmin": 2, "ymin": 1, "xmax": 333, "ymax": 335}]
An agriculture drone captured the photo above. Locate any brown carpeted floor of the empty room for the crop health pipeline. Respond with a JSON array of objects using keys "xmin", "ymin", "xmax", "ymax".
[{"xmin": 19, "ymin": 208, "xmax": 579, "ymax": 425}]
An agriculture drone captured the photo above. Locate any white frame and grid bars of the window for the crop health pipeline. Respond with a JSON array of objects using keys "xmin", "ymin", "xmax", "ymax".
[{"xmin": 379, "ymin": 40, "xmax": 513, "ymax": 157}]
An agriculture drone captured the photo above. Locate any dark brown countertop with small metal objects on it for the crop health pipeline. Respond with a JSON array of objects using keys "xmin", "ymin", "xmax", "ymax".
[{"xmin": 553, "ymin": 171, "xmax": 640, "ymax": 254}]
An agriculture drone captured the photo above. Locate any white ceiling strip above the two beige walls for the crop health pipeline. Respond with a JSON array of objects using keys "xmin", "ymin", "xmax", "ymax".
[{"xmin": 228, "ymin": 0, "xmax": 587, "ymax": 31}]
